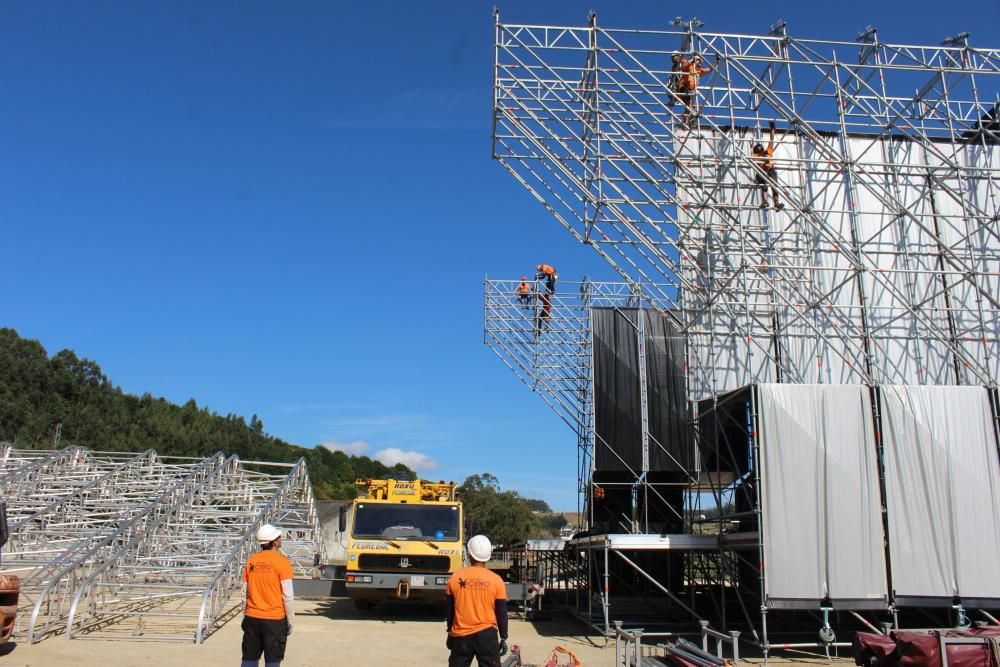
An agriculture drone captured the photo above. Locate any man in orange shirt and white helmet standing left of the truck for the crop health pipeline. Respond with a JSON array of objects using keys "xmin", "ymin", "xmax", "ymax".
[{"xmin": 241, "ymin": 524, "xmax": 295, "ymax": 667}]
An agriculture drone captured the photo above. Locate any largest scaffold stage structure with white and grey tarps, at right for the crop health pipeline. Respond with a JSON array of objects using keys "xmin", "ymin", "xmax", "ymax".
[{"xmin": 487, "ymin": 14, "xmax": 1000, "ymax": 650}]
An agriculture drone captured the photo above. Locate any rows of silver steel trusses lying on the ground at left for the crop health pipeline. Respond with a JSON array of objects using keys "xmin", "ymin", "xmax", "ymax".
[{"xmin": 0, "ymin": 445, "xmax": 324, "ymax": 643}]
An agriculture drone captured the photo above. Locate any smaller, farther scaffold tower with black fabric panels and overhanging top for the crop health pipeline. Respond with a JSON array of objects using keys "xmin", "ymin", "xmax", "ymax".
[{"xmin": 485, "ymin": 279, "xmax": 697, "ymax": 533}]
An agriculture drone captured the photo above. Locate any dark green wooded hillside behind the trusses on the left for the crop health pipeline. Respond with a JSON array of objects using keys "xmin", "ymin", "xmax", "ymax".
[{"xmin": 0, "ymin": 328, "xmax": 416, "ymax": 499}]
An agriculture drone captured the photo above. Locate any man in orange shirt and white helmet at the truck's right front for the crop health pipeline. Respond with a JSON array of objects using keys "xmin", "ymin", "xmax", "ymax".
[{"xmin": 445, "ymin": 535, "xmax": 507, "ymax": 667}]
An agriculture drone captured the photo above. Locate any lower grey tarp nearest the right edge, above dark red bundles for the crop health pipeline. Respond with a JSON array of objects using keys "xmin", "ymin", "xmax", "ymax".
[{"xmin": 879, "ymin": 385, "xmax": 1000, "ymax": 599}]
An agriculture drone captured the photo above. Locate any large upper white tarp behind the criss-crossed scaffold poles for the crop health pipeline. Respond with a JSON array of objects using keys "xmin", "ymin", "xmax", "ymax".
[{"xmin": 675, "ymin": 127, "xmax": 1000, "ymax": 398}]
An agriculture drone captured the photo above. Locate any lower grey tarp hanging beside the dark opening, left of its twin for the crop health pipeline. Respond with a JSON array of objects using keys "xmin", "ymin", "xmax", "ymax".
[{"xmin": 758, "ymin": 384, "xmax": 888, "ymax": 608}]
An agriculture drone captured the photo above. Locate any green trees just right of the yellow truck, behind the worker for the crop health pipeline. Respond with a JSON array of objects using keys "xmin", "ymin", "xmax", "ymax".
[{"xmin": 458, "ymin": 473, "xmax": 566, "ymax": 546}]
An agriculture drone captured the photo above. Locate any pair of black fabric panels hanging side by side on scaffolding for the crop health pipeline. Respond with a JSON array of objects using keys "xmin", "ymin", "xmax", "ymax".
[{"xmin": 591, "ymin": 308, "xmax": 693, "ymax": 472}]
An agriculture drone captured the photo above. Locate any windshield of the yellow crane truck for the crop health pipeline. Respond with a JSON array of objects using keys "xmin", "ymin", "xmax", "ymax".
[{"xmin": 353, "ymin": 503, "xmax": 461, "ymax": 542}]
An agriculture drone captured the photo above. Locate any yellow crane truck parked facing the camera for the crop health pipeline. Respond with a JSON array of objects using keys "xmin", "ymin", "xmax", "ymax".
[{"xmin": 341, "ymin": 479, "xmax": 463, "ymax": 610}]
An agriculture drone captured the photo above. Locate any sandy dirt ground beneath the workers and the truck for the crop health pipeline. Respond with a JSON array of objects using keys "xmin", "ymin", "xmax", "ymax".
[{"xmin": 0, "ymin": 599, "xmax": 853, "ymax": 667}]
